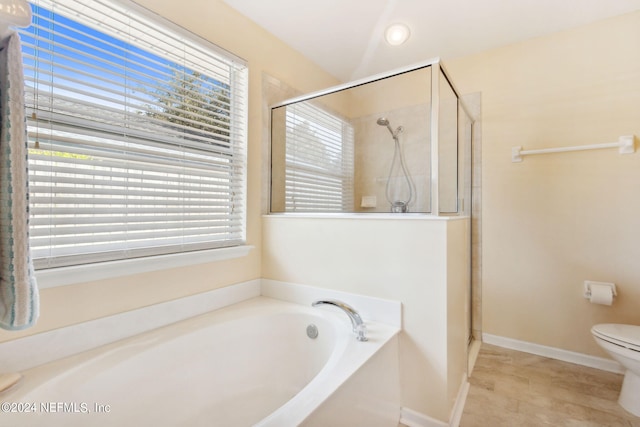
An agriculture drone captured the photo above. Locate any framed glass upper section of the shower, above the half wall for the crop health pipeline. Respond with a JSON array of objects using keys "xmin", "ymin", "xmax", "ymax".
[{"xmin": 270, "ymin": 59, "xmax": 473, "ymax": 215}]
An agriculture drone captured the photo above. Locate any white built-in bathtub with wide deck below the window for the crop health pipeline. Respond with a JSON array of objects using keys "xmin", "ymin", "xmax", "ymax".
[{"xmin": 0, "ymin": 296, "xmax": 399, "ymax": 427}]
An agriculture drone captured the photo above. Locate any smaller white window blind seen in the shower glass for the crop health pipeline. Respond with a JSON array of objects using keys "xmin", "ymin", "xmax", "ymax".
[{"xmin": 285, "ymin": 102, "xmax": 354, "ymax": 212}]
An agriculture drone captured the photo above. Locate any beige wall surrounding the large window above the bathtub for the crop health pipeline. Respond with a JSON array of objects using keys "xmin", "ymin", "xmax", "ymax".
[{"xmin": 0, "ymin": 0, "xmax": 338, "ymax": 342}]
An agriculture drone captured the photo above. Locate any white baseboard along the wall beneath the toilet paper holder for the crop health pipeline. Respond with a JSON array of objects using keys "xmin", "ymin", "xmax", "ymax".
[{"xmin": 482, "ymin": 333, "xmax": 625, "ymax": 374}]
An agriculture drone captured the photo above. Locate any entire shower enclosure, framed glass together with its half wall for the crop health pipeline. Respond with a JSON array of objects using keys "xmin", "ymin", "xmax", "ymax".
[{"xmin": 262, "ymin": 59, "xmax": 481, "ymax": 420}]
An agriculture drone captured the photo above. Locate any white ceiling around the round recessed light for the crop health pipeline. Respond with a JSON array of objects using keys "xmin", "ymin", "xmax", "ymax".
[{"xmin": 224, "ymin": 0, "xmax": 640, "ymax": 82}]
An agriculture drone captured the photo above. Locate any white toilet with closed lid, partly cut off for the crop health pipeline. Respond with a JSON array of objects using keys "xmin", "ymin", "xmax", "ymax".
[{"xmin": 591, "ymin": 323, "xmax": 640, "ymax": 417}]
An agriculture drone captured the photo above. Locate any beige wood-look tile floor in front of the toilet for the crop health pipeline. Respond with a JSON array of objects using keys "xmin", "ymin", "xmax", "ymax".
[{"xmin": 460, "ymin": 344, "xmax": 640, "ymax": 427}]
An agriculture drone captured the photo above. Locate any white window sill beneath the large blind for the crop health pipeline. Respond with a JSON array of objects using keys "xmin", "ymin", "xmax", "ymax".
[{"xmin": 36, "ymin": 245, "xmax": 254, "ymax": 289}]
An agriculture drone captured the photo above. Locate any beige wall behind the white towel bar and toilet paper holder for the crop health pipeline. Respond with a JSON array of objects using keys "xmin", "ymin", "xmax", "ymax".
[{"xmin": 447, "ymin": 12, "xmax": 640, "ymax": 356}]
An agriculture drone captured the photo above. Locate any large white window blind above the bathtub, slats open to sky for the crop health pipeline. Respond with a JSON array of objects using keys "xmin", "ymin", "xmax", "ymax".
[{"xmin": 21, "ymin": 0, "xmax": 247, "ymax": 268}]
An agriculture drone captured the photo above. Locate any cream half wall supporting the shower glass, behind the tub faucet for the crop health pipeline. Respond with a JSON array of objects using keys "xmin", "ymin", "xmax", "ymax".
[{"xmin": 262, "ymin": 215, "xmax": 470, "ymax": 421}]
